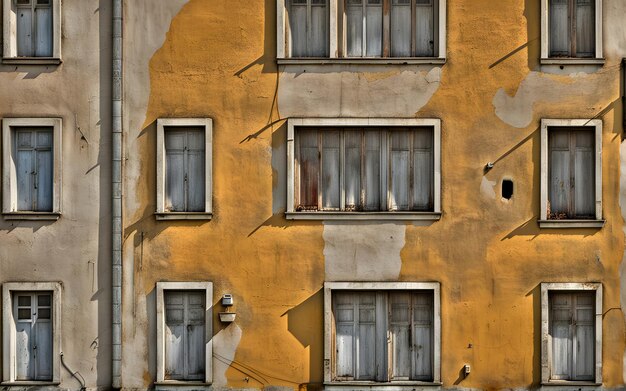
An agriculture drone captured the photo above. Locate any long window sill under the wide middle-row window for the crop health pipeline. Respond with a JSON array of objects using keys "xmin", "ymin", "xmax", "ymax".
[{"xmin": 285, "ymin": 212, "xmax": 441, "ymax": 221}]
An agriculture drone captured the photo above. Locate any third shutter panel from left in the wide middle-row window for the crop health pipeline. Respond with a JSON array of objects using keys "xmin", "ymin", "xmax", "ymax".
[{"xmin": 344, "ymin": 130, "xmax": 362, "ymax": 211}]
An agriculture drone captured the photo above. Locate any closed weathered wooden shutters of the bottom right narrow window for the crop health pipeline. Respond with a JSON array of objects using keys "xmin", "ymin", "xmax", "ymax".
[{"xmin": 549, "ymin": 292, "xmax": 595, "ymax": 380}]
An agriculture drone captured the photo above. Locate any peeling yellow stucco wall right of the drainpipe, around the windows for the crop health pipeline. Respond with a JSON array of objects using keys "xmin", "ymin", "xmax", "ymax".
[{"xmin": 123, "ymin": 0, "xmax": 626, "ymax": 390}]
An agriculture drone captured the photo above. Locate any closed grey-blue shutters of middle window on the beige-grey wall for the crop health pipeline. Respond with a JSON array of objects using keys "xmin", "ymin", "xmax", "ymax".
[{"xmin": 15, "ymin": 128, "xmax": 53, "ymax": 212}]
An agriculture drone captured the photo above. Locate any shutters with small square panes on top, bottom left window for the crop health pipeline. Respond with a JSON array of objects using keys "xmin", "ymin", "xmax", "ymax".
[{"xmin": 13, "ymin": 292, "xmax": 53, "ymax": 380}]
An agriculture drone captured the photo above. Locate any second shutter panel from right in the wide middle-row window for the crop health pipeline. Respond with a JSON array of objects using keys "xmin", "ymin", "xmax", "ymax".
[{"xmin": 389, "ymin": 130, "xmax": 411, "ymax": 210}]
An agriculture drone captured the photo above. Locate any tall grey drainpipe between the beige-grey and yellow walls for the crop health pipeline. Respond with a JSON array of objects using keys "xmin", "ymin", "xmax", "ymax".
[{"xmin": 111, "ymin": 0, "xmax": 123, "ymax": 389}]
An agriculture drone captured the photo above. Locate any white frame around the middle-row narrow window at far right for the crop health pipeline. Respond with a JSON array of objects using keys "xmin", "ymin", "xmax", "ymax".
[{"xmin": 538, "ymin": 119, "xmax": 605, "ymax": 228}]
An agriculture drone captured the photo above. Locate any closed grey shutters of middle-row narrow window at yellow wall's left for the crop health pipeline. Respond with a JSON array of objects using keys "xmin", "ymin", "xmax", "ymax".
[{"xmin": 165, "ymin": 127, "xmax": 206, "ymax": 212}]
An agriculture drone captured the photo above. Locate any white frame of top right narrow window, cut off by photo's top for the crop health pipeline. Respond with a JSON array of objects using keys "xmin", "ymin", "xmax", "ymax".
[{"xmin": 540, "ymin": 0, "xmax": 605, "ymax": 65}]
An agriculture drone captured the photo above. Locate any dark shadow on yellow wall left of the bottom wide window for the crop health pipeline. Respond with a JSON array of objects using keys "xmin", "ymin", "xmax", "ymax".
[{"xmin": 282, "ymin": 289, "xmax": 324, "ymax": 391}]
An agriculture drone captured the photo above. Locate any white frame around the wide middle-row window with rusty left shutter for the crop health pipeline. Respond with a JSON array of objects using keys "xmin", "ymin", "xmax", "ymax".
[{"xmin": 285, "ymin": 118, "xmax": 441, "ymax": 221}]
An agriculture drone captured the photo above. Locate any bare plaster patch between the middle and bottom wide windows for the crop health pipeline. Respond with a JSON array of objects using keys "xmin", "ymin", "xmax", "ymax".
[{"xmin": 323, "ymin": 222, "xmax": 406, "ymax": 281}]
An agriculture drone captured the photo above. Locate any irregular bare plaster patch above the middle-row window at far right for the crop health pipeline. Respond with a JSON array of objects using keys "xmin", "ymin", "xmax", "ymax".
[{"xmin": 492, "ymin": 72, "xmax": 609, "ymax": 129}]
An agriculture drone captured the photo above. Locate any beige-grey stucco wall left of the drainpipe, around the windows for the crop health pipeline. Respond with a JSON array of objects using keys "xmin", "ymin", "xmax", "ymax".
[{"xmin": 0, "ymin": 0, "xmax": 111, "ymax": 390}]
